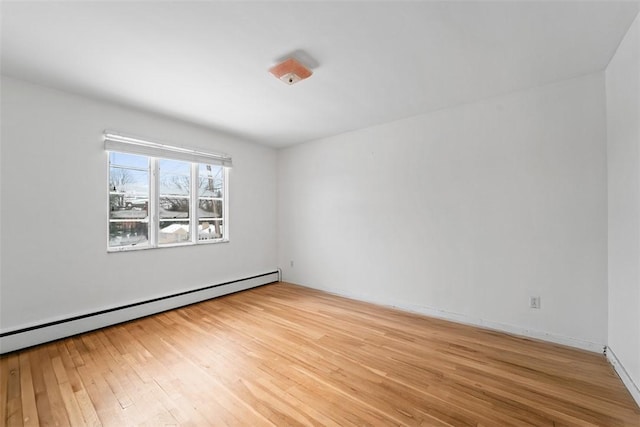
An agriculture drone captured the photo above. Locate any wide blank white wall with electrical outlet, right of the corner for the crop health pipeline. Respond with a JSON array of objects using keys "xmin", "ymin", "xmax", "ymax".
[{"xmin": 278, "ymin": 73, "xmax": 607, "ymax": 350}]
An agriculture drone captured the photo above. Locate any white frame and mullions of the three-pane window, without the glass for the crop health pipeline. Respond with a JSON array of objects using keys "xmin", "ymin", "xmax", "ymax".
[{"xmin": 105, "ymin": 132, "xmax": 231, "ymax": 252}]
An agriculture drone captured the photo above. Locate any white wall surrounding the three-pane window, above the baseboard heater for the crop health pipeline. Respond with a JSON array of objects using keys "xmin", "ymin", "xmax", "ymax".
[{"xmin": 0, "ymin": 78, "xmax": 277, "ymax": 338}]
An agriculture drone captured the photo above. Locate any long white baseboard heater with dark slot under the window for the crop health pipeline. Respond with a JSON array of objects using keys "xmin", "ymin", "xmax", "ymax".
[{"xmin": 0, "ymin": 271, "xmax": 279, "ymax": 354}]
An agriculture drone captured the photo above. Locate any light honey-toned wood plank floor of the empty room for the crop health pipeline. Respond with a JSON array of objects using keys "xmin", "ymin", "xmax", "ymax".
[{"xmin": 0, "ymin": 283, "xmax": 640, "ymax": 426}]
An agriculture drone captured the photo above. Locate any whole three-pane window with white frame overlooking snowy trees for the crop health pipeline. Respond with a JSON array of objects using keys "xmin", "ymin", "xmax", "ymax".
[{"xmin": 105, "ymin": 130, "xmax": 230, "ymax": 251}]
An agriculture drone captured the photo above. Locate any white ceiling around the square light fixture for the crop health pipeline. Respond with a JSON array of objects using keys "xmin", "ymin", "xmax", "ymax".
[{"xmin": 0, "ymin": 1, "xmax": 639, "ymax": 147}]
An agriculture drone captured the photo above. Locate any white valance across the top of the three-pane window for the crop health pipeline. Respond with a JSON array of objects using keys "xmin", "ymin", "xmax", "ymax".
[{"xmin": 104, "ymin": 131, "xmax": 232, "ymax": 167}]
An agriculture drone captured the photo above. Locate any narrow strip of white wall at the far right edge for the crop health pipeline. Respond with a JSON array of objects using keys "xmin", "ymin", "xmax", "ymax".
[{"xmin": 606, "ymin": 12, "xmax": 640, "ymax": 404}]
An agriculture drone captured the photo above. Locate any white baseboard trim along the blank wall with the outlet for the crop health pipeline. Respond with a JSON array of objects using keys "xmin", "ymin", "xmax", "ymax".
[{"xmin": 316, "ymin": 285, "xmax": 605, "ymax": 353}]
